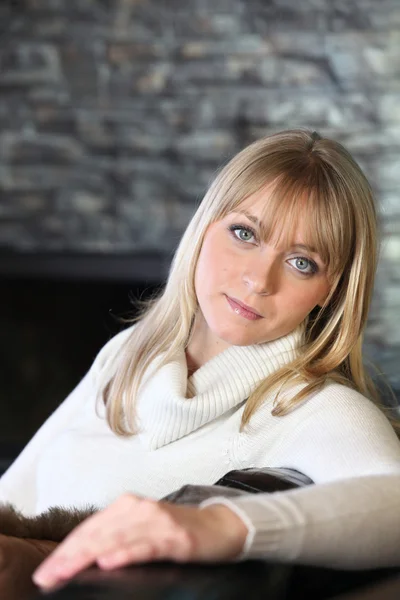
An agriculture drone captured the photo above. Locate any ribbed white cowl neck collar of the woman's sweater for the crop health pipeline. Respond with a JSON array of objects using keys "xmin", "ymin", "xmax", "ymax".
[{"xmin": 137, "ymin": 328, "xmax": 301, "ymax": 450}]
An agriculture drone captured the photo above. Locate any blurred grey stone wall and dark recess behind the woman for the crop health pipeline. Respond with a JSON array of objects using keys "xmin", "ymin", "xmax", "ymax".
[{"xmin": 0, "ymin": 0, "xmax": 400, "ymax": 459}]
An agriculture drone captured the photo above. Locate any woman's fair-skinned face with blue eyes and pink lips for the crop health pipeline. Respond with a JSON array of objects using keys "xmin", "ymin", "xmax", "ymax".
[{"xmin": 195, "ymin": 188, "xmax": 330, "ymax": 348}]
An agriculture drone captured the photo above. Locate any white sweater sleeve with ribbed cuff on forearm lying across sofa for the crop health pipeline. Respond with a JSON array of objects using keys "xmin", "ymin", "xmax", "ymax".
[{"xmin": 200, "ymin": 474, "xmax": 400, "ymax": 569}]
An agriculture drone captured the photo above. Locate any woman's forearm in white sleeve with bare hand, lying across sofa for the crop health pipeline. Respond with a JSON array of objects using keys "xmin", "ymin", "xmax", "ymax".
[{"xmin": 35, "ymin": 474, "xmax": 400, "ymax": 587}]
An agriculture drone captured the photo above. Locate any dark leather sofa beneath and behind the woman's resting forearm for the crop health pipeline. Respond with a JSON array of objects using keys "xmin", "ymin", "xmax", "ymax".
[{"xmin": 40, "ymin": 468, "xmax": 400, "ymax": 600}]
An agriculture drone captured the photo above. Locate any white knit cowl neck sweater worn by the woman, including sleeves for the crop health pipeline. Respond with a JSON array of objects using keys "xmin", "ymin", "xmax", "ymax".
[{"xmin": 0, "ymin": 330, "xmax": 400, "ymax": 566}]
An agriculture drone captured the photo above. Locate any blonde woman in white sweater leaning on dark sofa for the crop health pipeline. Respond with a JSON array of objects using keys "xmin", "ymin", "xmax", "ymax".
[{"xmin": 0, "ymin": 130, "xmax": 400, "ymax": 585}]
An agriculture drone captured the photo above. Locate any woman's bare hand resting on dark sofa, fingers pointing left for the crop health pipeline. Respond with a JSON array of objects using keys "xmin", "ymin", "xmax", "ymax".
[{"xmin": 34, "ymin": 494, "xmax": 248, "ymax": 587}]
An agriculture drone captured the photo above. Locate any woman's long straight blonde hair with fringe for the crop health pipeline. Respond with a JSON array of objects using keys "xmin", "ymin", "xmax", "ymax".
[{"xmin": 103, "ymin": 130, "xmax": 396, "ymax": 435}]
